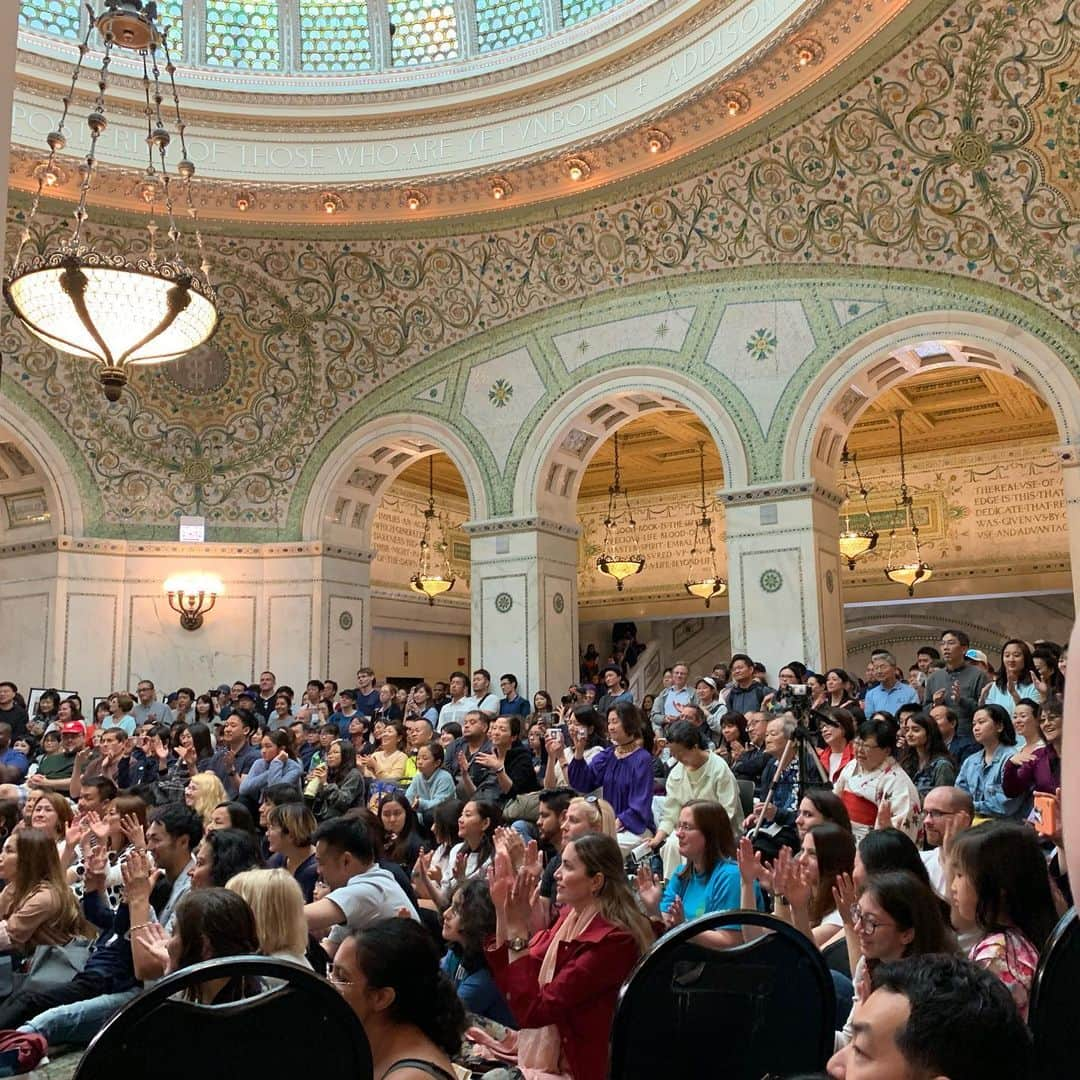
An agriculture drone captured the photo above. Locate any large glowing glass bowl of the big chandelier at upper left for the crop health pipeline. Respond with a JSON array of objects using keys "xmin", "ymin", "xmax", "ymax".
[{"xmin": 4, "ymin": 252, "xmax": 218, "ymax": 401}]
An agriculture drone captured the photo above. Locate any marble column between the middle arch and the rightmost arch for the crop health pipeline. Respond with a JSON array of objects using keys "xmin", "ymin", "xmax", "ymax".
[{"xmin": 719, "ymin": 481, "xmax": 845, "ymax": 680}]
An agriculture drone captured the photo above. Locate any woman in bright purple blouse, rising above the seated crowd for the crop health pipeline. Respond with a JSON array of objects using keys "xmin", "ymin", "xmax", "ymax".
[{"xmin": 566, "ymin": 701, "xmax": 656, "ymax": 851}]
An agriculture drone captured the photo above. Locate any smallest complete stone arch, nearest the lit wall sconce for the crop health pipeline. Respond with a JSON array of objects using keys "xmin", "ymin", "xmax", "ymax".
[{"xmin": 302, "ymin": 414, "xmax": 488, "ymax": 549}]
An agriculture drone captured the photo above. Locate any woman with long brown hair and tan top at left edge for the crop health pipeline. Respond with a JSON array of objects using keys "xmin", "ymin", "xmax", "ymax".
[{"xmin": 0, "ymin": 828, "xmax": 94, "ymax": 949}]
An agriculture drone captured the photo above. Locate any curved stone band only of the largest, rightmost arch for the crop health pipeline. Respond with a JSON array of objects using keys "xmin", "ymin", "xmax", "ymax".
[{"xmin": 783, "ymin": 311, "xmax": 1080, "ymax": 484}]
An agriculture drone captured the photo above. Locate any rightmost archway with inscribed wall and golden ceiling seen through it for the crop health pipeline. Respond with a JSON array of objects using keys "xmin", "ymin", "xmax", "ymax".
[{"xmin": 785, "ymin": 316, "xmax": 1080, "ymax": 660}]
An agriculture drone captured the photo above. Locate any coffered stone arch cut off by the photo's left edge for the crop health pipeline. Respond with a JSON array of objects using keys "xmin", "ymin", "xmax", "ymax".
[{"xmin": 0, "ymin": 393, "xmax": 83, "ymax": 541}]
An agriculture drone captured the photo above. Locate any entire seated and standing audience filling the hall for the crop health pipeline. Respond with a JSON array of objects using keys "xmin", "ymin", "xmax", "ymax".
[{"xmin": 0, "ymin": 630, "xmax": 1071, "ymax": 1080}]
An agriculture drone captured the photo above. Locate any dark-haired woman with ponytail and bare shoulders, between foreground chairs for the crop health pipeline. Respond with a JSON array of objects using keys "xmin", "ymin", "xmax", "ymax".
[{"xmin": 329, "ymin": 919, "xmax": 465, "ymax": 1080}]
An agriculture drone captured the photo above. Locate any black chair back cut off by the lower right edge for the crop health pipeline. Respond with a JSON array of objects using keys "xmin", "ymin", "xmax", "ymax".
[{"xmin": 1027, "ymin": 907, "xmax": 1080, "ymax": 1077}]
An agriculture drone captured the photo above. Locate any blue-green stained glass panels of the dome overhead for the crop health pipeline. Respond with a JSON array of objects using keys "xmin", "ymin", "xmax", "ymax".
[{"xmin": 19, "ymin": 0, "xmax": 631, "ymax": 75}]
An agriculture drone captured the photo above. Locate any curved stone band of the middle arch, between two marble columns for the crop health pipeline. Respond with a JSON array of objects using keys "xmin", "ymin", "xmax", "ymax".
[{"xmin": 513, "ymin": 366, "xmax": 750, "ymax": 524}]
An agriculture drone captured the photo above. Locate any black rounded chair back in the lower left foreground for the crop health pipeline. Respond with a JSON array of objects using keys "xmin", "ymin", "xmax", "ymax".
[{"xmin": 73, "ymin": 957, "xmax": 375, "ymax": 1080}]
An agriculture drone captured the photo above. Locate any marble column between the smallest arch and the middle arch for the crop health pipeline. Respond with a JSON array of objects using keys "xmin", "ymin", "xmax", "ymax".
[{"xmin": 464, "ymin": 517, "xmax": 578, "ymax": 702}]
